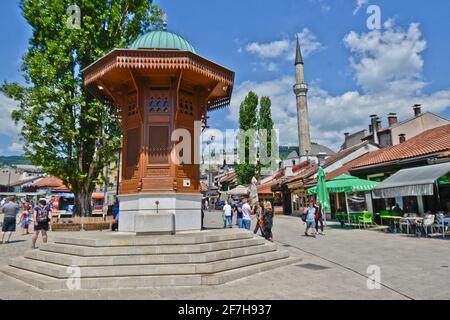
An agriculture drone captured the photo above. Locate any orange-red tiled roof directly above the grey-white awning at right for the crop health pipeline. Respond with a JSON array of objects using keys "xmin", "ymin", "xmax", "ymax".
[{"xmin": 353, "ymin": 125, "xmax": 450, "ymax": 168}]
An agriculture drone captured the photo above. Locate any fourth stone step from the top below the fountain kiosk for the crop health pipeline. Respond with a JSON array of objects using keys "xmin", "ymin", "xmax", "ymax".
[{"xmin": 10, "ymin": 251, "xmax": 289, "ymax": 279}]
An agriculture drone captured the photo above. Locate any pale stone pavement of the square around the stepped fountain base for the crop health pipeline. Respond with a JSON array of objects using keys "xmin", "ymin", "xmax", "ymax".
[{"xmin": 0, "ymin": 212, "xmax": 450, "ymax": 300}]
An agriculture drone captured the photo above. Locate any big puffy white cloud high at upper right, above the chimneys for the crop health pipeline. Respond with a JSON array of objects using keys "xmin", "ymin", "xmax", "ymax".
[{"xmin": 344, "ymin": 20, "xmax": 427, "ymax": 92}]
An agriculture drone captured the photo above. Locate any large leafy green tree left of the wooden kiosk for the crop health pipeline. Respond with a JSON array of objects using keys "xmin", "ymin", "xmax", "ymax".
[{"xmin": 1, "ymin": 0, "xmax": 162, "ymax": 216}]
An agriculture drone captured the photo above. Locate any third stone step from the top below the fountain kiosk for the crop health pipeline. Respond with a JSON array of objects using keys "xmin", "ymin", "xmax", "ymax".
[{"xmin": 25, "ymin": 242, "xmax": 277, "ymax": 267}]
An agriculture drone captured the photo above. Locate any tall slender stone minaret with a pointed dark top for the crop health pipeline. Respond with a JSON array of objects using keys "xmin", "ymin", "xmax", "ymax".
[{"xmin": 294, "ymin": 37, "xmax": 311, "ymax": 159}]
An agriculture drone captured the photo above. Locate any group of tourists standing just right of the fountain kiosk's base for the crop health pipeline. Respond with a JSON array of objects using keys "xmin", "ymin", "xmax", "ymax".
[{"xmin": 223, "ymin": 198, "xmax": 273, "ymax": 240}]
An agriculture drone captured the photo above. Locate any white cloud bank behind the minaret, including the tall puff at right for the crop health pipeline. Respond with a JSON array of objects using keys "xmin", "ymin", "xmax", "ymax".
[{"xmin": 228, "ymin": 21, "xmax": 450, "ymax": 150}]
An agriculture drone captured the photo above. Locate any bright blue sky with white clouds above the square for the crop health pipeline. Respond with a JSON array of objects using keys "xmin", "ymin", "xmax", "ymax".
[{"xmin": 0, "ymin": 0, "xmax": 450, "ymax": 155}]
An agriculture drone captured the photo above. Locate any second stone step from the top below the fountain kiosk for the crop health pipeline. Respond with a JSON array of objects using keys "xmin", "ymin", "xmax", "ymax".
[{"xmin": 39, "ymin": 237, "xmax": 267, "ymax": 257}]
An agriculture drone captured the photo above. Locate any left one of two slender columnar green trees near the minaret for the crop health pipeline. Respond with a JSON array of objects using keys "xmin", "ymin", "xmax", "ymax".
[{"xmin": 236, "ymin": 91, "xmax": 258, "ymax": 184}]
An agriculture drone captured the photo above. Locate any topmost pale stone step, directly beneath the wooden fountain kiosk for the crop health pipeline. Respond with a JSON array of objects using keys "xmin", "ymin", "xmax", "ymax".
[{"xmin": 54, "ymin": 229, "xmax": 254, "ymax": 247}]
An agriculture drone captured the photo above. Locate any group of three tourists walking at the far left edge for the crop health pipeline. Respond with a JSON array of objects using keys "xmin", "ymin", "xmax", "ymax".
[{"xmin": 0, "ymin": 197, "xmax": 52, "ymax": 249}]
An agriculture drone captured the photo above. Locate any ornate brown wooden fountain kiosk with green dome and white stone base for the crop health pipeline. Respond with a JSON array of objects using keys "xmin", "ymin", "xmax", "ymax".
[{"xmin": 84, "ymin": 30, "xmax": 234, "ymax": 233}]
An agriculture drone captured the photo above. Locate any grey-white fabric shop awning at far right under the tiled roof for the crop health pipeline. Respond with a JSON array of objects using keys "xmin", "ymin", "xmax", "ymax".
[{"xmin": 372, "ymin": 162, "xmax": 450, "ymax": 199}]
